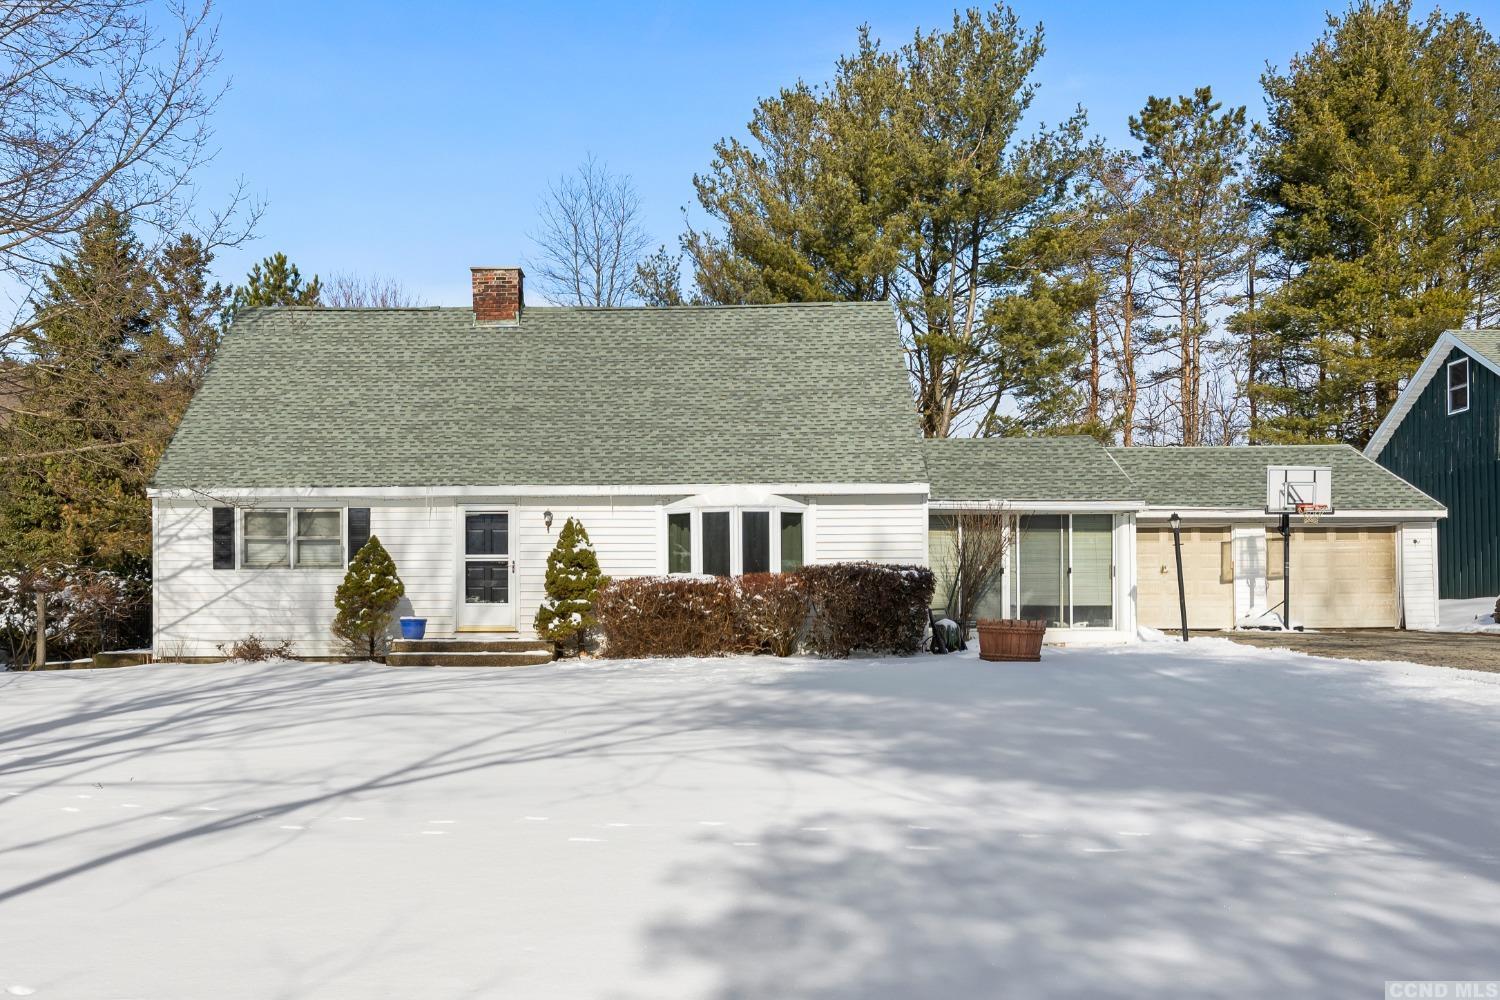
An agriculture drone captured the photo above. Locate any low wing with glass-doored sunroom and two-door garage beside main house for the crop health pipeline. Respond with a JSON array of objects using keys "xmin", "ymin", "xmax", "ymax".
[{"xmin": 926, "ymin": 438, "xmax": 1443, "ymax": 632}]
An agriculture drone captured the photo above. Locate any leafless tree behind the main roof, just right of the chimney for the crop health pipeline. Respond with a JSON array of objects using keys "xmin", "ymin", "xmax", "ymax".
[{"xmin": 528, "ymin": 156, "xmax": 651, "ymax": 306}]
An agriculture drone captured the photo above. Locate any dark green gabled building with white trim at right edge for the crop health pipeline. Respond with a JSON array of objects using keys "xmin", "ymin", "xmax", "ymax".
[{"xmin": 1365, "ymin": 330, "xmax": 1500, "ymax": 598}]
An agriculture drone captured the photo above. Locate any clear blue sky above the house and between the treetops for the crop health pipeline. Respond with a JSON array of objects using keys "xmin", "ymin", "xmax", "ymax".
[{"xmin": 200, "ymin": 0, "xmax": 1500, "ymax": 304}]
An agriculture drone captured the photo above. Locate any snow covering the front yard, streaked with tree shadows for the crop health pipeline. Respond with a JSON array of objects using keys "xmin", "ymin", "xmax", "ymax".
[{"xmin": 0, "ymin": 639, "xmax": 1500, "ymax": 1000}]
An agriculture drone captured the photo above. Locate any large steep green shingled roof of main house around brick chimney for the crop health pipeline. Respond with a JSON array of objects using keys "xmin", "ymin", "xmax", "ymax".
[{"xmin": 155, "ymin": 303, "xmax": 927, "ymax": 489}]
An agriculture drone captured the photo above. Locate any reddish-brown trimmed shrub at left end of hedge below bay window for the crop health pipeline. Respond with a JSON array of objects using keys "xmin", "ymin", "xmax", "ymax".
[{"xmin": 594, "ymin": 576, "xmax": 753, "ymax": 658}]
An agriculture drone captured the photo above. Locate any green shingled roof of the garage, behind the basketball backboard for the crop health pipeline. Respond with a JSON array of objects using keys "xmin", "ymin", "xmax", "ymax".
[{"xmin": 1110, "ymin": 444, "xmax": 1443, "ymax": 513}]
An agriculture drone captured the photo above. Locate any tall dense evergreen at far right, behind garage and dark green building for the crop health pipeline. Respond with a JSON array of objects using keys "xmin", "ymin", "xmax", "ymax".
[{"xmin": 1242, "ymin": 0, "xmax": 1500, "ymax": 444}]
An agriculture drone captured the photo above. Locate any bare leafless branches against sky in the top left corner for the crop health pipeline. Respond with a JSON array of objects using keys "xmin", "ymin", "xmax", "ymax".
[{"xmin": 0, "ymin": 0, "xmax": 249, "ymax": 271}]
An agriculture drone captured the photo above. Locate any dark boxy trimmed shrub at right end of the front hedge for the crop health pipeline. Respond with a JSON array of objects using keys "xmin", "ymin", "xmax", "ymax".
[{"xmin": 798, "ymin": 562, "xmax": 933, "ymax": 658}]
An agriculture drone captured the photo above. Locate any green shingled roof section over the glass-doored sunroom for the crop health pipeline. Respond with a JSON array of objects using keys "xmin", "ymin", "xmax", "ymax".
[{"xmin": 924, "ymin": 438, "xmax": 1143, "ymax": 504}]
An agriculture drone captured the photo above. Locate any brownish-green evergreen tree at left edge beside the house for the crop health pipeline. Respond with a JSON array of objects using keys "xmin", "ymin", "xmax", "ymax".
[{"xmin": 0, "ymin": 205, "xmax": 162, "ymax": 570}]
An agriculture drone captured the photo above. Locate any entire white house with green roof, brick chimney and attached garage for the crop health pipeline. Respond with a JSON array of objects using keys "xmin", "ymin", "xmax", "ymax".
[{"xmin": 150, "ymin": 268, "xmax": 1442, "ymax": 657}]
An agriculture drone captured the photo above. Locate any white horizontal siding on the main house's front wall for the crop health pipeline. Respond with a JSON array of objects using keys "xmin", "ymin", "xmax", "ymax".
[{"xmin": 155, "ymin": 485, "xmax": 927, "ymax": 657}]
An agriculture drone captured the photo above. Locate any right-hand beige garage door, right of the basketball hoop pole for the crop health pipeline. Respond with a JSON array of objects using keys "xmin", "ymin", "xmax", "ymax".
[{"xmin": 1268, "ymin": 525, "xmax": 1401, "ymax": 628}]
